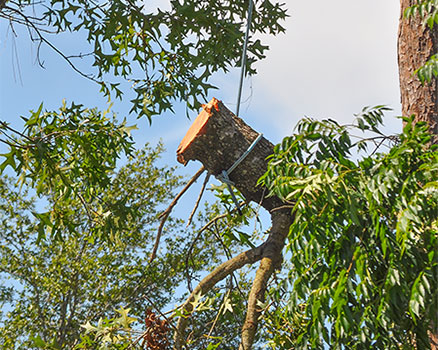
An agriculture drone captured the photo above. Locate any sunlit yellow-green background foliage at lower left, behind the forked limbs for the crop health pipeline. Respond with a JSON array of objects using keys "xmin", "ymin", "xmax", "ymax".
[{"xmin": 0, "ymin": 141, "xmax": 264, "ymax": 350}]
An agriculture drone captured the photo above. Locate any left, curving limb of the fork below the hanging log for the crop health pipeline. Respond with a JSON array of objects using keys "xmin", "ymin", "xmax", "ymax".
[{"xmin": 174, "ymin": 244, "xmax": 265, "ymax": 350}]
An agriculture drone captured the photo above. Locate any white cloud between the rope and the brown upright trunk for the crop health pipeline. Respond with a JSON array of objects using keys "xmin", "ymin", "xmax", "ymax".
[{"xmin": 236, "ymin": 0, "xmax": 400, "ymax": 136}]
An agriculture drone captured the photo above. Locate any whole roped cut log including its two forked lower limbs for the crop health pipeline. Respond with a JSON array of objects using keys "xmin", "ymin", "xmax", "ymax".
[{"xmin": 174, "ymin": 98, "xmax": 292, "ymax": 350}]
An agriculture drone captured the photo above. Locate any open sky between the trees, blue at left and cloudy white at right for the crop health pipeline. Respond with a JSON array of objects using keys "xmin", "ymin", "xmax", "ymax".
[{"xmin": 0, "ymin": 0, "xmax": 401, "ymax": 219}]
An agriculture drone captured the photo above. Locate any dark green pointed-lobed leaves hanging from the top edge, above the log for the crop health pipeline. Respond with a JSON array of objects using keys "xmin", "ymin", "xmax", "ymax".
[{"xmin": 2, "ymin": 0, "xmax": 286, "ymax": 121}]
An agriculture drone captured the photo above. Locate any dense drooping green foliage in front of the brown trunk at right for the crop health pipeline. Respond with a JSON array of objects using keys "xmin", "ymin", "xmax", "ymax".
[{"xmin": 261, "ymin": 107, "xmax": 438, "ymax": 349}]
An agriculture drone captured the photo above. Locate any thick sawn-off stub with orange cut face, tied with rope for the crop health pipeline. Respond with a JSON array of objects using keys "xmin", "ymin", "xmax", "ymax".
[{"xmin": 177, "ymin": 98, "xmax": 282, "ymax": 211}]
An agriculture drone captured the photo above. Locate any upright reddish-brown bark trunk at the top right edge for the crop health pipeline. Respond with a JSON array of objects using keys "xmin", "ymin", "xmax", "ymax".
[{"xmin": 398, "ymin": 0, "xmax": 438, "ymax": 143}]
